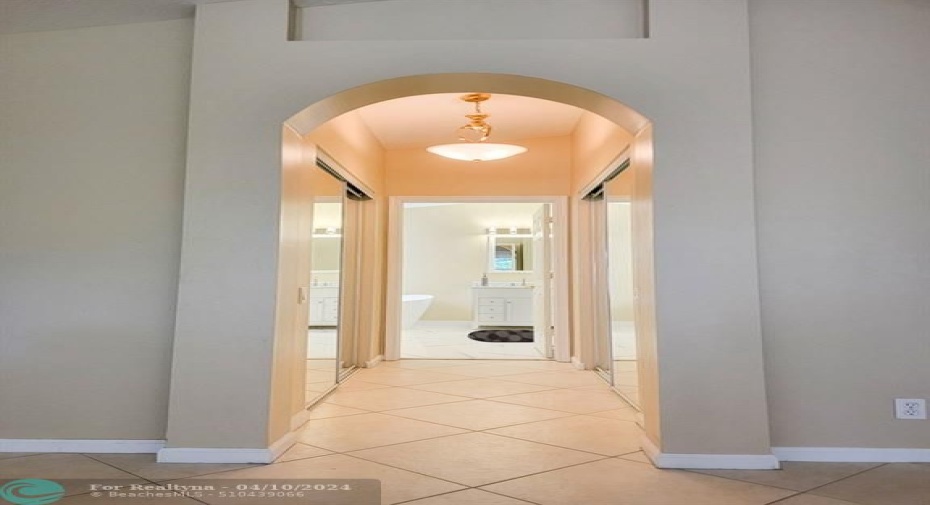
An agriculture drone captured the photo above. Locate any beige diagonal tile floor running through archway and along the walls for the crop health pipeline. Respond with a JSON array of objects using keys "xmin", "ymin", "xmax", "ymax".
[{"xmin": 0, "ymin": 360, "xmax": 930, "ymax": 505}]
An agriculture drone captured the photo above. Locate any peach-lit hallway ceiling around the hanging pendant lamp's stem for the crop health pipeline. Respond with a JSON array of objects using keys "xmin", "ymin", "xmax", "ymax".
[{"xmin": 356, "ymin": 93, "xmax": 584, "ymax": 149}]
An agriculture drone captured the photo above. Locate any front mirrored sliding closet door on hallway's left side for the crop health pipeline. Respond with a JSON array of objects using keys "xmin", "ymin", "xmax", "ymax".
[{"xmin": 306, "ymin": 167, "xmax": 345, "ymax": 402}]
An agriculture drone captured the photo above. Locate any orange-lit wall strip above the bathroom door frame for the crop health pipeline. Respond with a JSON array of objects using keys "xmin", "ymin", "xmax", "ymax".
[{"xmin": 385, "ymin": 136, "xmax": 571, "ymax": 196}]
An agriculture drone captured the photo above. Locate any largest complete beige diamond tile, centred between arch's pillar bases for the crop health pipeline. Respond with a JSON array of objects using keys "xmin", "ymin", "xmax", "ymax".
[{"xmin": 352, "ymin": 433, "xmax": 599, "ymax": 486}]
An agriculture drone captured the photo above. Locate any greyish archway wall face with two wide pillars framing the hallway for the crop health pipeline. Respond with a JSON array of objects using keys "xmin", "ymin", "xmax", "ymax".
[{"xmin": 169, "ymin": 0, "xmax": 769, "ymax": 454}]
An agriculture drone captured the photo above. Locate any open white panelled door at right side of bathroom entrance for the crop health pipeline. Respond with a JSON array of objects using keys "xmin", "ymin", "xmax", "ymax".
[{"xmin": 533, "ymin": 204, "xmax": 553, "ymax": 358}]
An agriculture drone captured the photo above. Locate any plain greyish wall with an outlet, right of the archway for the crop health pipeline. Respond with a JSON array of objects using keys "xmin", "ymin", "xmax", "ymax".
[{"xmin": 751, "ymin": 0, "xmax": 930, "ymax": 448}]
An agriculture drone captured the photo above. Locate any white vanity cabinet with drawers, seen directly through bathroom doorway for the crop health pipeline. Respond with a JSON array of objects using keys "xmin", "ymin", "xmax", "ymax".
[{"xmin": 471, "ymin": 286, "xmax": 533, "ymax": 326}]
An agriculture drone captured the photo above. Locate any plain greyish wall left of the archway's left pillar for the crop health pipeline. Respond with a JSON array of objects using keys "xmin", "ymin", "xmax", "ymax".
[{"xmin": 0, "ymin": 20, "xmax": 192, "ymax": 439}]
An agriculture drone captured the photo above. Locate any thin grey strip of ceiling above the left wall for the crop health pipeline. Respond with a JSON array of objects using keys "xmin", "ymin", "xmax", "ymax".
[{"xmin": 0, "ymin": 0, "xmax": 392, "ymax": 33}]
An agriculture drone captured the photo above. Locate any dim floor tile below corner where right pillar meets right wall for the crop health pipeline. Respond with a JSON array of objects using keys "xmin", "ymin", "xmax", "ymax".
[{"xmin": 695, "ymin": 461, "xmax": 880, "ymax": 491}]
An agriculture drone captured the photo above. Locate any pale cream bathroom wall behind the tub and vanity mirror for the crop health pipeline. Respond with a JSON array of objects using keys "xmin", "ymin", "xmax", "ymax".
[{"xmin": 403, "ymin": 203, "xmax": 541, "ymax": 321}]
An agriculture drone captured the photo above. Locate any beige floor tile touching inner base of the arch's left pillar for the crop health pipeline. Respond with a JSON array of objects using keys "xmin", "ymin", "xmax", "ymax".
[{"xmin": 298, "ymin": 413, "xmax": 464, "ymax": 452}]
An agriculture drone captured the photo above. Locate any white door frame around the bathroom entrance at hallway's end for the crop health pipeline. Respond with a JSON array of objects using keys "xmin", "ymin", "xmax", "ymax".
[{"xmin": 384, "ymin": 196, "xmax": 571, "ymax": 362}]
